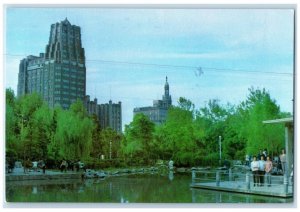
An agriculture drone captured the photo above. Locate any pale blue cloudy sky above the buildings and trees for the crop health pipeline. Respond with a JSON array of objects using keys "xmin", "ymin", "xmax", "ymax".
[{"xmin": 4, "ymin": 7, "xmax": 294, "ymax": 128}]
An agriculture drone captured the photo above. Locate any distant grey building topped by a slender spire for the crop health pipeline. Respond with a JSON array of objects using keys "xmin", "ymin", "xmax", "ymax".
[{"xmin": 133, "ymin": 77, "xmax": 172, "ymax": 124}]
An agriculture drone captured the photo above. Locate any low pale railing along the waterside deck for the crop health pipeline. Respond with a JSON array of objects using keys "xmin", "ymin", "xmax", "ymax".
[{"xmin": 192, "ymin": 169, "xmax": 293, "ymax": 194}]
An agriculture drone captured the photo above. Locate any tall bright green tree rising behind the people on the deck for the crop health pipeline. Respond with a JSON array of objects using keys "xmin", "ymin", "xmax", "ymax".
[{"xmin": 244, "ymin": 87, "xmax": 284, "ymax": 154}]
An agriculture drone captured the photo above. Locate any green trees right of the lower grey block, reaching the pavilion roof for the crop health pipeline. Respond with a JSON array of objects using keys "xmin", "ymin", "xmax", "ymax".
[{"xmin": 121, "ymin": 87, "xmax": 291, "ymax": 166}]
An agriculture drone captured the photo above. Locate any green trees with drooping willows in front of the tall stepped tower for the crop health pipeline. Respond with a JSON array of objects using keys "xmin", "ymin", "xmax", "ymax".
[{"xmin": 6, "ymin": 89, "xmax": 121, "ymax": 168}]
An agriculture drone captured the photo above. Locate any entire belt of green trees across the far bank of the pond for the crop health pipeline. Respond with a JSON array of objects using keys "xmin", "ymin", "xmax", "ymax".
[{"xmin": 6, "ymin": 88, "xmax": 291, "ymax": 168}]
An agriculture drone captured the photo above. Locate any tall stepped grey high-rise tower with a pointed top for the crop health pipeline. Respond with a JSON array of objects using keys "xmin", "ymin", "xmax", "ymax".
[{"xmin": 18, "ymin": 18, "xmax": 86, "ymax": 109}]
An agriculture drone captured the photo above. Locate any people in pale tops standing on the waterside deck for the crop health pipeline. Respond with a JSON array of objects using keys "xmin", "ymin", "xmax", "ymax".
[{"xmin": 250, "ymin": 149, "xmax": 286, "ymax": 186}]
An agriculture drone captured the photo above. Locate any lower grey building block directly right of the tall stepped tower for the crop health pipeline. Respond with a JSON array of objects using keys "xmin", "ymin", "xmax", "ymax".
[{"xmin": 84, "ymin": 95, "xmax": 122, "ymax": 133}]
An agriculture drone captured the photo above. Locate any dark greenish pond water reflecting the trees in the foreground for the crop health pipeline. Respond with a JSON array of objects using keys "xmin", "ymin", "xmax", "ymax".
[{"xmin": 6, "ymin": 173, "xmax": 293, "ymax": 203}]
